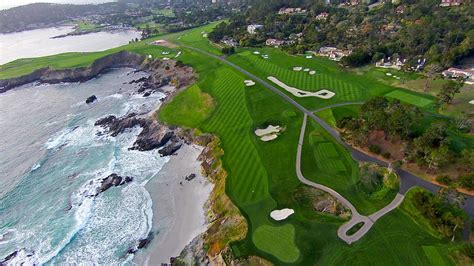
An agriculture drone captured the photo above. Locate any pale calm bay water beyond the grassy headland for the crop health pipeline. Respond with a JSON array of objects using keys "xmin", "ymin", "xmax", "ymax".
[{"xmin": 0, "ymin": 26, "xmax": 140, "ymax": 65}]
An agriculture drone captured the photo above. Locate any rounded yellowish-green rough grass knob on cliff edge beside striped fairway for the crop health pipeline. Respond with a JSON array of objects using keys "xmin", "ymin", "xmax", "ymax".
[{"xmin": 159, "ymin": 85, "xmax": 215, "ymax": 128}]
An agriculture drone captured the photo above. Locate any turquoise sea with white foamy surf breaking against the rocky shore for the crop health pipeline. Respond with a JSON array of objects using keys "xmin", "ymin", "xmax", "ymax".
[{"xmin": 0, "ymin": 69, "xmax": 169, "ymax": 265}]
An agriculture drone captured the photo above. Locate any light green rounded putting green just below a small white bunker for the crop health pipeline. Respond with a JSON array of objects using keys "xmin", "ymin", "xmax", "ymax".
[{"xmin": 252, "ymin": 224, "xmax": 300, "ymax": 263}]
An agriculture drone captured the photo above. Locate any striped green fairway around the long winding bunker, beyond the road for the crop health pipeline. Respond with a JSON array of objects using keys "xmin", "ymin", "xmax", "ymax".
[{"xmin": 229, "ymin": 48, "xmax": 394, "ymax": 110}]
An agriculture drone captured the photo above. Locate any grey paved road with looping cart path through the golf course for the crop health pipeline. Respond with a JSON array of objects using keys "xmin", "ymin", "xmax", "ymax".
[{"xmin": 180, "ymin": 44, "xmax": 474, "ymax": 241}]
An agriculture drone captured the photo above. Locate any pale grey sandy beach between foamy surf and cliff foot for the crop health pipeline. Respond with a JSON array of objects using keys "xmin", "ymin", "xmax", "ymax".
[{"xmin": 134, "ymin": 145, "xmax": 212, "ymax": 265}]
